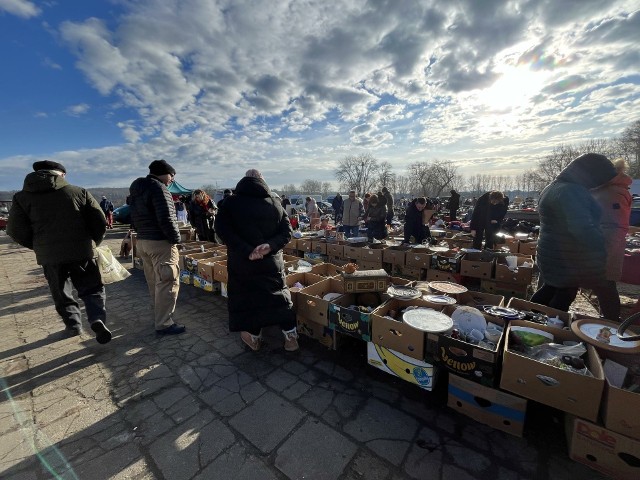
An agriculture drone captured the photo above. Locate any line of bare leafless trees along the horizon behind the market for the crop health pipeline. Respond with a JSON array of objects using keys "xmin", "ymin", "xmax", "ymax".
[{"xmin": 281, "ymin": 120, "xmax": 640, "ymax": 202}]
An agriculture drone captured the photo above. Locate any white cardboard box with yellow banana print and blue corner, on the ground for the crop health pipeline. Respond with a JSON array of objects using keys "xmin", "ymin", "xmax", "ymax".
[{"xmin": 367, "ymin": 342, "xmax": 436, "ymax": 391}]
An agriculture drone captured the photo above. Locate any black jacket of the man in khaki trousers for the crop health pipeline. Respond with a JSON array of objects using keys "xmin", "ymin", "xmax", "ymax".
[{"xmin": 129, "ymin": 175, "xmax": 180, "ymax": 245}]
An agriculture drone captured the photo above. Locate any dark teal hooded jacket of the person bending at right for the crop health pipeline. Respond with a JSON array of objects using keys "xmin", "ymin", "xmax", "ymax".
[{"xmin": 537, "ymin": 153, "xmax": 616, "ymax": 288}]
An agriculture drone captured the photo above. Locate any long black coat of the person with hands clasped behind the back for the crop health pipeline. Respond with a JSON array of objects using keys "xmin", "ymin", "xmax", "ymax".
[{"xmin": 215, "ymin": 177, "xmax": 295, "ymax": 332}]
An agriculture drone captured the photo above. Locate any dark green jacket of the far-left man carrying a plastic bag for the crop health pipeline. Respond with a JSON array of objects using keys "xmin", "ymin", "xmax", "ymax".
[{"xmin": 7, "ymin": 170, "xmax": 107, "ymax": 265}]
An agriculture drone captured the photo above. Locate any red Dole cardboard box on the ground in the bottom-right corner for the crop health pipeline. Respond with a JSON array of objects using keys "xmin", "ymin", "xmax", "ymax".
[{"xmin": 565, "ymin": 415, "xmax": 640, "ymax": 480}]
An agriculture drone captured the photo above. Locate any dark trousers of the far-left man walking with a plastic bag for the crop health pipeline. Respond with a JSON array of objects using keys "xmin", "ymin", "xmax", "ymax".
[{"xmin": 42, "ymin": 258, "xmax": 107, "ymax": 328}]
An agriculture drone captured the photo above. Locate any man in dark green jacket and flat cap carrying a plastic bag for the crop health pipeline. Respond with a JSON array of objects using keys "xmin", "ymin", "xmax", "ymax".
[{"xmin": 7, "ymin": 160, "xmax": 111, "ymax": 343}]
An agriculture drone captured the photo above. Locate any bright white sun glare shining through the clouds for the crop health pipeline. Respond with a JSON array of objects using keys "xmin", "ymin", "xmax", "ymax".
[{"xmin": 478, "ymin": 67, "xmax": 546, "ymax": 110}]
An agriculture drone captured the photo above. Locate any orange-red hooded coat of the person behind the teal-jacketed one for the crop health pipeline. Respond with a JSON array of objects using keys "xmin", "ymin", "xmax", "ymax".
[{"xmin": 592, "ymin": 173, "xmax": 633, "ymax": 281}]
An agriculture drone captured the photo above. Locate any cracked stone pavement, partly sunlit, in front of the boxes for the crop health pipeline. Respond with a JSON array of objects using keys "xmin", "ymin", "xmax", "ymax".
[{"xmin": 0, "ymin": 230, "xmax": 602, "ymax": 480}]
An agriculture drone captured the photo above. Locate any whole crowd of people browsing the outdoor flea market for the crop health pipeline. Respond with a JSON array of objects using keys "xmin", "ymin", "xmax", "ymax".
[{"xmin": 7, "ymin": 154, "xmax": 631, "ymax": 351}]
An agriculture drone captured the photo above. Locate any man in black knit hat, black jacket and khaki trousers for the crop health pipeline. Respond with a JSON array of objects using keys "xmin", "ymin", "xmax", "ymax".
[{"xmin": 129, "ymin": 160, "xmax": 186, "ymax": 335}]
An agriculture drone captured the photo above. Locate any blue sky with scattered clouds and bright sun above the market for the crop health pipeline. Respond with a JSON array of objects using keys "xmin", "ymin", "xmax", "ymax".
[{"xmin": 0, "ymin": 0, "xmax": 640, "ymax": 190}]
